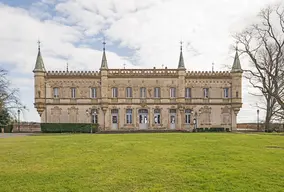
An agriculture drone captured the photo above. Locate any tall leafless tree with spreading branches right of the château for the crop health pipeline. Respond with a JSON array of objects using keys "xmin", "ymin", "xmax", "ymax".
[{"xmin": 234, "ymin": 5, "xmax": 284, "ymax": 128}]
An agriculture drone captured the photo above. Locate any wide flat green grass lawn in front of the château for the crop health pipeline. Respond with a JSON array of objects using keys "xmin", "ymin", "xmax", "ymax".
[{"xmin": 0, "ymin": 133, "xmax": 284, "ymax": 192}]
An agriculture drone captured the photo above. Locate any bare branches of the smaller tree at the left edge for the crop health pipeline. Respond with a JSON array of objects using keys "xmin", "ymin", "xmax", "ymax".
[{"xmin": 0, "ymin": 69, "xmax": 25, "ymax": 121}]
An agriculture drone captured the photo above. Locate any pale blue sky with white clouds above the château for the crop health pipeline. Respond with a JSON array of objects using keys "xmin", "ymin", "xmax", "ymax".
[{"xmin": 0, "ymin": 0, "xmax": 279, "ymax": 123}]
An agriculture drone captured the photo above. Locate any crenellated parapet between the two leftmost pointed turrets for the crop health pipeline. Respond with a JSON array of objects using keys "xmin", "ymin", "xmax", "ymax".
[{"xmin": 46, "ymin": 71, "xmax": 100, "ymax": 78}]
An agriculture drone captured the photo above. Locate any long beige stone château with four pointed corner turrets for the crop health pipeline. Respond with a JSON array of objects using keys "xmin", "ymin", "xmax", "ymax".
[{"xmin": 33, "ymin": 42, "xmax": 243, "ymax": 131}]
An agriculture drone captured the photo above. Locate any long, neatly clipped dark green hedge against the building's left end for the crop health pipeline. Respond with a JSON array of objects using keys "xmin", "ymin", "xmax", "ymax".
[{"xmin": 40, "ymin": 123, "xmax": 98, "ymax": 133}]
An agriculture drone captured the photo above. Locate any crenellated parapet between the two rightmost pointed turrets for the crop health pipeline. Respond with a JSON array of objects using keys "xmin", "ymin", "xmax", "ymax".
[{"xmin": 185, "ymin": 71, "xmax": 231, "ymax": 79}]
